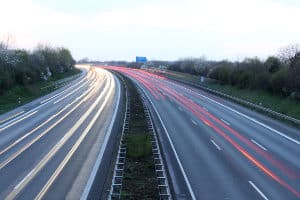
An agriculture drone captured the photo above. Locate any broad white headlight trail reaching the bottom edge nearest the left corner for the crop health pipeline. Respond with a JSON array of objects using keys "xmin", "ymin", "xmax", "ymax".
[{"xmin": 5, "ymin": 71, "xmax": 110, "ymax": 199}]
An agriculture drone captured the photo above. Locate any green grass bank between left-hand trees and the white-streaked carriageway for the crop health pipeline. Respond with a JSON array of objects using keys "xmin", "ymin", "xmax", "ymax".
[{"xmin": 0, "ymin": 70, "xmax": 80, "ymax": 114}]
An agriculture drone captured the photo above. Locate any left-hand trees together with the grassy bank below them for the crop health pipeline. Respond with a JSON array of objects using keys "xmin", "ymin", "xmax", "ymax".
[{"xmin": 0, "ymin": 42, "xmax": 80, "ymax": 113}]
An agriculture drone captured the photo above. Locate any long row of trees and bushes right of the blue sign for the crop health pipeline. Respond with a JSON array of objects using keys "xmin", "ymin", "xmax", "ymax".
[{"xmin": 168, "ymin": 46, "xmax": 300, "ymax": 99}]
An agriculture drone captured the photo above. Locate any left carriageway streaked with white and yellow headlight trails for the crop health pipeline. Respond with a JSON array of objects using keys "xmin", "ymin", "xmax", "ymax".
[{"xmin": 0, "ymin": 67, "xmax": 122, "ymax": 199}]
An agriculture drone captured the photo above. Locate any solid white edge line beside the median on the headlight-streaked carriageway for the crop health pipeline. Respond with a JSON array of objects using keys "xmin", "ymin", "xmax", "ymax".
[{"xmin": 80, "ymin": 71, "xmax": 121, "ymax": 200}]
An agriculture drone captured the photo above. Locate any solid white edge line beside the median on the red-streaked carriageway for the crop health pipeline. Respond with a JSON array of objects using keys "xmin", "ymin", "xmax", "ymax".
[{"xmin": 140, "ymin": 81, "xmax": 196, "ymax": 200}]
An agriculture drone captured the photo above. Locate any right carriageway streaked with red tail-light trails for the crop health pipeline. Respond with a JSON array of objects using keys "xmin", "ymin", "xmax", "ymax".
[{"xmin": 110, "ymin": 67, "xmax": 300, "ymax": 200}]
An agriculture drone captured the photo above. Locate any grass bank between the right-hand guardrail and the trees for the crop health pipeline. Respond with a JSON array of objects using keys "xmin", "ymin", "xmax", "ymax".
[{"xmin": 155, "ymin": 71, "xmax": 300, "ymax": 119}]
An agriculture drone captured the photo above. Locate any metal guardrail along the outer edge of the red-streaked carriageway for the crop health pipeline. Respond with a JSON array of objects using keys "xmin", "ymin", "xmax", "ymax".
[{"xmin": 167, "ymin": 76, "xmax": 300, "ymax": 125}]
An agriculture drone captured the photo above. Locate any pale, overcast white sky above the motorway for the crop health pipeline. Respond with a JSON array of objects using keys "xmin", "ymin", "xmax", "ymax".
[{"xmin": 0, "ymin": 0, "xmax": 300, "ymax": 61}]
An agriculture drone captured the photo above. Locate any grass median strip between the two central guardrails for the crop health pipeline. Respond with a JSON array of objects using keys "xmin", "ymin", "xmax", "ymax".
[{"xmin": 121, "ymin": 78, "xmax": 159, "ymax": 199}]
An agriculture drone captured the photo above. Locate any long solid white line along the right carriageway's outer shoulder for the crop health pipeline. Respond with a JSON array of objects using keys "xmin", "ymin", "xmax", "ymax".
[{"xmin": 193, "ymin": 91, "xmax": 300, "ymax": 144}]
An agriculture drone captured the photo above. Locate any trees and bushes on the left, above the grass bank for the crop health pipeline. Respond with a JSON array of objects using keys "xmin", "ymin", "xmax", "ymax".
[{"xmin": 0, "ymin": 43, "xmax": 75, "ymax": 94}]
